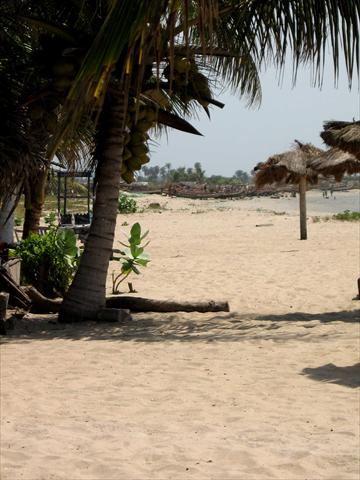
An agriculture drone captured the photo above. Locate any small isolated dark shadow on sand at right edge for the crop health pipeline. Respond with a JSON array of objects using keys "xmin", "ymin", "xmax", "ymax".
[{"xmin": 302, "ymin": 363, "xmax": 360, "ymax": 388}]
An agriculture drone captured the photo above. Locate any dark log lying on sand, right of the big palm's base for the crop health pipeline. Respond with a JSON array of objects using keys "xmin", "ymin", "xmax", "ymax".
[{"xmin": 106, "ymin": 295, "xmax": 230, "ymax": 313}]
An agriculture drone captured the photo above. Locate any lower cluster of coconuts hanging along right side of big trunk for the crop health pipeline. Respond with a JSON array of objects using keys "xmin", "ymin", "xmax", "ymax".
[{"xmin": 121, "ymin": 102, "xmax": 156, "ymax": 183}]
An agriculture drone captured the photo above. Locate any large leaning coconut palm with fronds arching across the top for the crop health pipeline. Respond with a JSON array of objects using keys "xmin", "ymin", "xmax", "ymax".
[{"xmin": 60, "ymin": 0, "xmax": 360, "ymax": 320}]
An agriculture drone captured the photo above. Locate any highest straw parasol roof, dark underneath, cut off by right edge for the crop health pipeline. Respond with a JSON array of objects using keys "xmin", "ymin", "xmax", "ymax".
[{"xmin": 320, "ymin": 121, "xmax": 360, "ymax": 160}]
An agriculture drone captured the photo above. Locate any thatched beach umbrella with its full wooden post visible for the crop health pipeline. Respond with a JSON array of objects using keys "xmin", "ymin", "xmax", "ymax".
[{"xmin": 254, "ymin": 140, "xmax": 323, "ymax": 240}]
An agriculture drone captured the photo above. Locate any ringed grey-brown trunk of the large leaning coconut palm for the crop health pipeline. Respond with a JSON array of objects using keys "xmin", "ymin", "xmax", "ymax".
[{"xmin": 59, "ymin": 93, "xmax": 126, "ymax": 322}]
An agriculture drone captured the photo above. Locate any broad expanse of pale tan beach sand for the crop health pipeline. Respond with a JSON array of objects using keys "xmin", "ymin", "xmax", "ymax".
[{"xmin": 0, "ymin": 191, "xmax": 360, "ymax": 480}]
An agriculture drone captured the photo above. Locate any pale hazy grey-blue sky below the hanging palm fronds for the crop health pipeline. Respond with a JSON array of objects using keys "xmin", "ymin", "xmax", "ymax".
[{"xmin": 151, "ymin": 62, "xmax": 360, "ymax": 176}]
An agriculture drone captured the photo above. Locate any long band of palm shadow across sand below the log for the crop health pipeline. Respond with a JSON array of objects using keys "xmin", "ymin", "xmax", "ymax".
[{"xmin": 2, "ymin": 311, "xmax": 360, "ymax": 343}]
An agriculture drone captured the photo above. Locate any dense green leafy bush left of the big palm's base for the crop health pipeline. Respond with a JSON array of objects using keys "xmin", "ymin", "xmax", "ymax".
[{"xmin": 12, "ymin": 227, "xmax": 79, "ymax": 296}]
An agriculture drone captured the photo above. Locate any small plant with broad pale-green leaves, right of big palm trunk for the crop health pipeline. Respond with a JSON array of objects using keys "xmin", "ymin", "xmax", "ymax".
[{"xmin": 112, "ymin": 223, "xmax": 150, "ymax": 294}]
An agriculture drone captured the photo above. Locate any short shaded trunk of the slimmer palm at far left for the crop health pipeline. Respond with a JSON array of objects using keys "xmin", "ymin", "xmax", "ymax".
[{"xmin": 22, "ymin": 166, "xmax": 49, "ymax": 238}]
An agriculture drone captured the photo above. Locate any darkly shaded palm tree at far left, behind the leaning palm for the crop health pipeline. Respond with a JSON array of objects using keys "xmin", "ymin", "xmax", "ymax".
[{"xmin": 0, "ymin": 0, "xmax": 97, "ymax": 237}]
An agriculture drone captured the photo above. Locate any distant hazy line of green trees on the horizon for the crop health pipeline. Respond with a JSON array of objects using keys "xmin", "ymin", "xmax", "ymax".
[{"xmin": 137, "ymin": 162, "xmax": 252, "ymax": 185}]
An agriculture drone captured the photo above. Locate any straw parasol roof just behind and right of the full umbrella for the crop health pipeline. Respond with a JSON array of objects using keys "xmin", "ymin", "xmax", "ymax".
[{"xmin": 309, "ymin": 148, "xmax": 360, "ymax": 182}]
